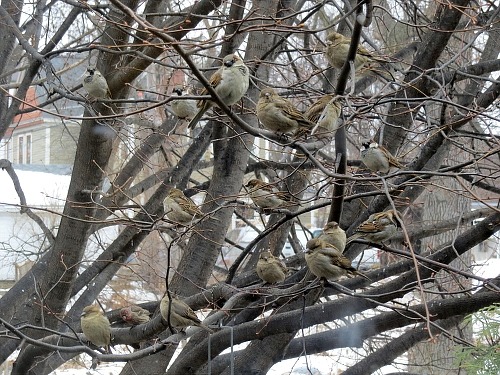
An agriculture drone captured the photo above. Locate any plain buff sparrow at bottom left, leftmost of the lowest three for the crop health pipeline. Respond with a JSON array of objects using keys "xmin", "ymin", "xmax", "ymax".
[{"xmin": 80, "ymin": 305, "xmax": 111, "ymax": 353}]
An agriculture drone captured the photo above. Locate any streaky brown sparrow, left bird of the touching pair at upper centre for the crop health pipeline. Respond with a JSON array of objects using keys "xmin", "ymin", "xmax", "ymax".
[{"xmin": 257, "ymin": 87, "xmax": 315, "ymax": 134}]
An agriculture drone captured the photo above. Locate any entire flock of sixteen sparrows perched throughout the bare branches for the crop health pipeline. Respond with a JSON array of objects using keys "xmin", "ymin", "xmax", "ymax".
[{"xmin": 81, "ymin": 32, "xmax": 403, "ymax": 352}]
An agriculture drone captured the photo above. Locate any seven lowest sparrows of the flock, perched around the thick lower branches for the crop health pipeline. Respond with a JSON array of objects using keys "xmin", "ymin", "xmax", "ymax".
[{"xmin": 81, "ymin": 210, "xmax": 400, "ymax": 353}]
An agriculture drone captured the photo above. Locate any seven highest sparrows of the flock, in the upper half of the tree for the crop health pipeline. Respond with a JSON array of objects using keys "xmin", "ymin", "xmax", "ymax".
[{"xmin": 83, "ymin": 32, "xmax": 402, "ymax": 173}]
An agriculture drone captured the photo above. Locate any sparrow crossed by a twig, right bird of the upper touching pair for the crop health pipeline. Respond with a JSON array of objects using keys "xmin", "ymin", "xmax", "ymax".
[{"xmin": 305, "ymin": 94, "xmax": 342, "ymax": 136}]
